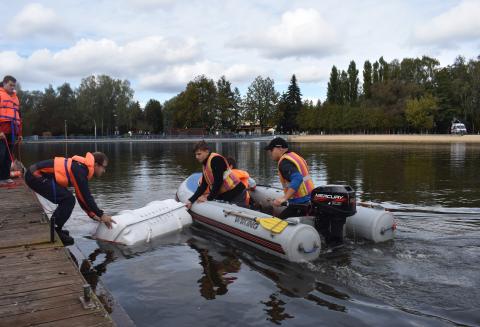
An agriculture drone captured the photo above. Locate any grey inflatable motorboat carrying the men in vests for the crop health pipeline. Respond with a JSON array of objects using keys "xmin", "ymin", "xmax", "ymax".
[{"xmin": 177, "ymin": 173, "xmax": 396, "ymax": 261}]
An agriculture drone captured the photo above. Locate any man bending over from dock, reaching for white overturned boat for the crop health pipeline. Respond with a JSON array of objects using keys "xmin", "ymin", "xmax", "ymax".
[{"xmin": 25, "ymin": 152, "xmax": 116, "ymax": 245}]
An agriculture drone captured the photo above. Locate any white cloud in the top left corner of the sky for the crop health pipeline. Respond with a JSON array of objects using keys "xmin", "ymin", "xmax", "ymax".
[{"xmin": 5, "ymin": 3, "xmax": 70, "ymax": 38}]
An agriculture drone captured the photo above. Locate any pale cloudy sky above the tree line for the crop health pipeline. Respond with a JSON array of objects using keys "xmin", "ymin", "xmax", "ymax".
[{"xmin": 0, "ymin": 0, "xmax": 480, "ymax": 103}]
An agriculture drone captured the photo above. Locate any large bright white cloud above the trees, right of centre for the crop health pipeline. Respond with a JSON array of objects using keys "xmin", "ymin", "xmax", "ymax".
[{"xmin": 229, "ymin": 9, "xmax": 339, "ymax": 58}]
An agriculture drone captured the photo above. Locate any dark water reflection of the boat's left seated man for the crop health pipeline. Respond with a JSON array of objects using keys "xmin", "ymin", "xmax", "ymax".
[{"xmin": 188, "ymin": 241, "xmax": 241, "ymax": 300}]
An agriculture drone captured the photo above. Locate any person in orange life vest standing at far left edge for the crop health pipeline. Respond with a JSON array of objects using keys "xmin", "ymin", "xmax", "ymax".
[{"xmin": 0, "ymin": 75, "xmax": 22, "ymax": 185}]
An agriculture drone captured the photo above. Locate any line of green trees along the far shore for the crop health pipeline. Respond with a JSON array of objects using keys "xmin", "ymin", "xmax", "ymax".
[{"xmin": 18, "ymin": 56, "xmax": 480, "ymax": 135}]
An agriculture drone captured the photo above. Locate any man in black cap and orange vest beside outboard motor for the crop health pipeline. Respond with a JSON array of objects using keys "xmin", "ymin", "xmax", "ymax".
[{"xmin": 265, "ymin": 137, "xmax": 314, "ymax": 219}]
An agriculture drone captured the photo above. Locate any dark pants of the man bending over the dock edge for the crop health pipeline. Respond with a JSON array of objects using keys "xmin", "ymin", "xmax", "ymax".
[{"xmin": 25, "ymin": 170, "xmax": 75, "ymax": 229}]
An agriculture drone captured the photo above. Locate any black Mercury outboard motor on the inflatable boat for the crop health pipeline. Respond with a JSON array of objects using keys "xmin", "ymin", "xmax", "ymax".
[{"xmin": 311, "ymin": 185, "xmax": 357, "ymax": 247}]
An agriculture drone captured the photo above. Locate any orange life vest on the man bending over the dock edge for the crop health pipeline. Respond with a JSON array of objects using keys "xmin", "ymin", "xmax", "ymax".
[{"xmin": 53, "ymin": 152, "xmax": 95, "ymax": 187}]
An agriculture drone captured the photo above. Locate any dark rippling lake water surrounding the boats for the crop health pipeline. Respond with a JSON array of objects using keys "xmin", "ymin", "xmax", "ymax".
[{"xmin": 18, "ymin": 141, "xmax": 480, "ymax": 327}]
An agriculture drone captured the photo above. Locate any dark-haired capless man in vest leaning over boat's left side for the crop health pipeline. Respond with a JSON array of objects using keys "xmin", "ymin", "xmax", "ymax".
[{"xmin": 186, "ymin": 141, "xmax": 246, "ymax": 209}]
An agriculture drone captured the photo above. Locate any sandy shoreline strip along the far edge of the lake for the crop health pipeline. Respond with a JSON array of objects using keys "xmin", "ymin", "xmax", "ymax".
[{"xmin": 24, "ymin": 134, "xmax": 480, "ymax": 144}]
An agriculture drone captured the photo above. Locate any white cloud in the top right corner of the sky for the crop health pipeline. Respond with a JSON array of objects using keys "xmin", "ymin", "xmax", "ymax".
[{"xmin": 412, "ymin": 0, "xmax": 480, "ymax": 47}]
